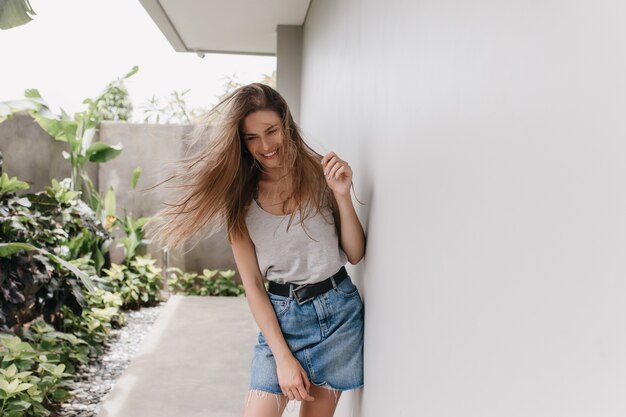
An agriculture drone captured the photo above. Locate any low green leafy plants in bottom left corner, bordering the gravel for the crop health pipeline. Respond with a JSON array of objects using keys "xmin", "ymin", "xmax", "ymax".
[{"xmin": 0, "ymin": 282, "xmax": 124, "ymax": 416}]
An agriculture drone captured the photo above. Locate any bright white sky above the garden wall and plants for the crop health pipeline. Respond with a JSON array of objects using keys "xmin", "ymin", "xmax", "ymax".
[{"xmin": 0, "ymin": 0, "xmax": 276, "ymax": 119}]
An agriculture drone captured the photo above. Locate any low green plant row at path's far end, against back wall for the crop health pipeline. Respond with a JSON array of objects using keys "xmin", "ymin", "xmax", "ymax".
[{"xmin": 168, "ymin": 268, "xmax": 244, "ymax": 296}]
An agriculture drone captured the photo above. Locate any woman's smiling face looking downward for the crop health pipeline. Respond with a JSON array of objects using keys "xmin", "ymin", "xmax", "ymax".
[{"xmin": 242, "ymin": 110, "xmax": 284, "ymax": 170}]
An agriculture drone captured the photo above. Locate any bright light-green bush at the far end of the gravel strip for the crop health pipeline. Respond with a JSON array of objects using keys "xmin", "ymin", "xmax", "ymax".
[{"xmin": 104, "ymin": 255, "xmax": 163, "ymax": 309}]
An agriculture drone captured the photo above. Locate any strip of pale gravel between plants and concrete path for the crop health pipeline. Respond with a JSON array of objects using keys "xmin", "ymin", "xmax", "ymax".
[{"xmin": 56, "ymin": 303, "xmax": 165, "ymax": 417}]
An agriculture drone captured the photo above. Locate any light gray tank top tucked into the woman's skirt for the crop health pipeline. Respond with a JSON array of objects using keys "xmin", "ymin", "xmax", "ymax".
[{"xmin": 246, "ymin": 195, "xmax": 347, "ymax": 284}]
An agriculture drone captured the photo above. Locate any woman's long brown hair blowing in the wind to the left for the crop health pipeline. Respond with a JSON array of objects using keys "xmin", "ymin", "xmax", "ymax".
[{"xmin": 146, "ymin": 83, "xmax": 337, "ymax": 247}]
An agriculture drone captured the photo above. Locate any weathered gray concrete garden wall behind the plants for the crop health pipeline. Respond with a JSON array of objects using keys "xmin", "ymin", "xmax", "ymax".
[{"xmin": 0, "ymin": 115, "xmax": 236, "ymax": 272}]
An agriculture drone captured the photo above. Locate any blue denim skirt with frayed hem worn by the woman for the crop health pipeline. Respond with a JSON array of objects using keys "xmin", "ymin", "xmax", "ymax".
[{"xmin": 250, "ymin": 276, "xmax": 363, "ymax": 394}]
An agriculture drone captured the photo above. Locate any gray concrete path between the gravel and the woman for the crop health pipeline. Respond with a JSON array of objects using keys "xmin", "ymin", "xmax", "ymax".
[{"xmin": 98, "ymin": 295, "xmax": 299, "ymax": 417}]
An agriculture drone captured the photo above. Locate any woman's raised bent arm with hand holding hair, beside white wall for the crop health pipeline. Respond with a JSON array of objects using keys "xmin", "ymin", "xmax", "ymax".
[{"xmin": 322, "ymin": 152, "xmax": 365, "ymax": 265}]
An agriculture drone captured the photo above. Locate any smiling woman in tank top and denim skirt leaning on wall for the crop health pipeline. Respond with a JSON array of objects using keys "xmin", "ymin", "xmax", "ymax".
[{"xmin": 150, "ymin": 84, "xmax": 365, "ymax": 417}]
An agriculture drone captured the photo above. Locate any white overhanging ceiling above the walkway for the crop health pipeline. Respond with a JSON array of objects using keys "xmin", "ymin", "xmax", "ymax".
[{"xmin": 139, "ymin": 0, "xmax": 310, "ymax": 55}]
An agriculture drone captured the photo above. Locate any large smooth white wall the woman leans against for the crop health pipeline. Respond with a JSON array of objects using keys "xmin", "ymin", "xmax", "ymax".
[{"xmin": 301, "ymin": 0, "xmax": 626, "ymax": 417}]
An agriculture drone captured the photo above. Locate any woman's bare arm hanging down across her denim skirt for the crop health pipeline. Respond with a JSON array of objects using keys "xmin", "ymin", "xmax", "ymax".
[{"xmin": 231, "ymin": 233, "xmax": 314, "ymax": 401}]
